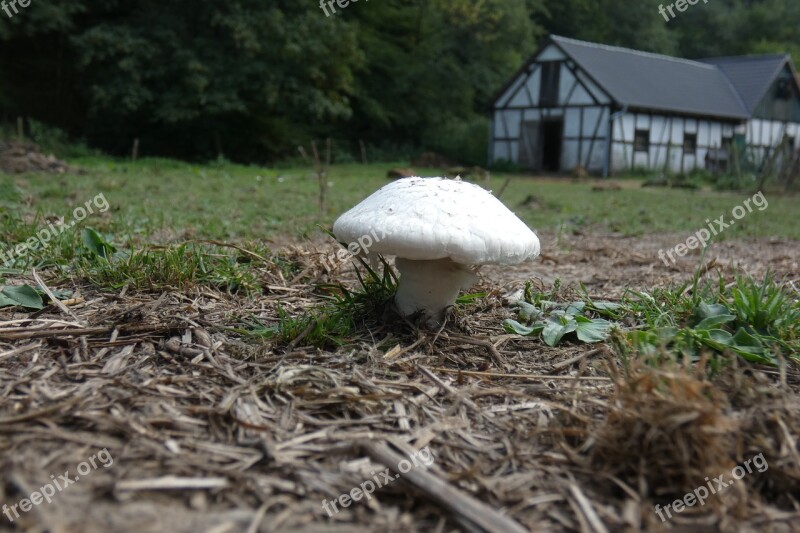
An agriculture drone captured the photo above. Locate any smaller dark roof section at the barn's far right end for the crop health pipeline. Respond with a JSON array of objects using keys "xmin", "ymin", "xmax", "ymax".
[{"xmin": 701, "ymin": 54, "xmax": 789, "ymax": 113}]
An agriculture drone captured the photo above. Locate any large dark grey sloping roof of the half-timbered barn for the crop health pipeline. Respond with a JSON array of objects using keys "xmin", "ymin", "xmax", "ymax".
[{"xmin": 551, "ymin": 35, "xmax": 749, "ymax": 119}]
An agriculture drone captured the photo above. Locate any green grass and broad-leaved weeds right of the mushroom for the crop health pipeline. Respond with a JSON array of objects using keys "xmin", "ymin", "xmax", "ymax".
[{"xmin": 503, "ymin": 262, "xmax": 800, "ymax": 364}]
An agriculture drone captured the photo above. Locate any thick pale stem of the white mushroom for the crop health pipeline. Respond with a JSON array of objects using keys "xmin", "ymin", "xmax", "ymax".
[{"xmin": 395, "ymin": 257, "xmax": 478, "ymax": 325}]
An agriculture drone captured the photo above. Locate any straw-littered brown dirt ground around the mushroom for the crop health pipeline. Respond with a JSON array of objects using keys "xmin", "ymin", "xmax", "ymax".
[{"xmin": 0, "ymin": 233, "xmax": 800, "ymax": 533}]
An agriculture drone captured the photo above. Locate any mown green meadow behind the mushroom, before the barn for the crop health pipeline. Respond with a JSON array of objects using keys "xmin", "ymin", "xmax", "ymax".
[{"xmin": 0, "ymin": 157, "xmax": 800, "ymax": 261}]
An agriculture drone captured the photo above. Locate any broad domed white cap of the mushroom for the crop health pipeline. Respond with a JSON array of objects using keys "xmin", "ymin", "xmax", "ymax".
[{"xmin": 333, "ymin": 177, "xmax": 539, "ymax": 265}]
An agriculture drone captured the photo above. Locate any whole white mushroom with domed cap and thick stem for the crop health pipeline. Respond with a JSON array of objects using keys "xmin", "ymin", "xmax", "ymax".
[{"xmin": 333, "ymin": 177, "xmax": 539, "ymax": 325}]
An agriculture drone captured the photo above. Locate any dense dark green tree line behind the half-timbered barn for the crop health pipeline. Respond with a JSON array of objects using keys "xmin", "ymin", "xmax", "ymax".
[{"xmin": 0, "ymin": 0, "xmax": 800, "ymax": 163}]
